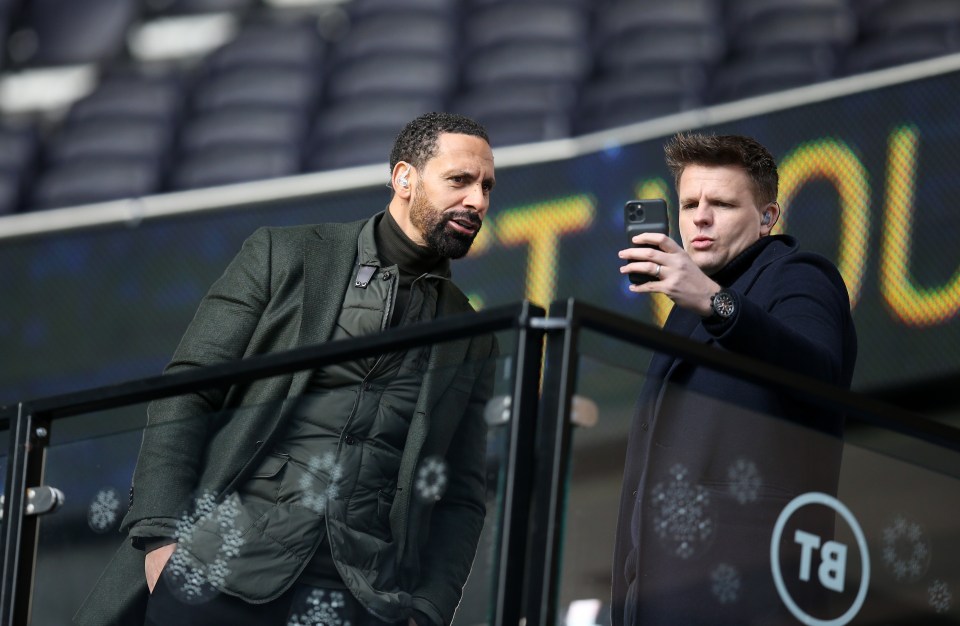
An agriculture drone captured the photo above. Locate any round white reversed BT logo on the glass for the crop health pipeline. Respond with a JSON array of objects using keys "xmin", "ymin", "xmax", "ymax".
[{"xmin": 770, "ymin": 492, "xmax": 870, "ymax": 626}]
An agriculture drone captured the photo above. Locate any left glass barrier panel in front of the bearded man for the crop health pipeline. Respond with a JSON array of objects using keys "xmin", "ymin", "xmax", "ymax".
[{"xmin": 22, "ymin": 333, "xmax": 515, "ymax": 626}]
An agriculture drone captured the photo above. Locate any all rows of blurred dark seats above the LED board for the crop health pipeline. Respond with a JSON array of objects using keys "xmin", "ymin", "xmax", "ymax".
[{"xmin": 0, "ymin": 0, "xmax": 960, "ymax": 213}]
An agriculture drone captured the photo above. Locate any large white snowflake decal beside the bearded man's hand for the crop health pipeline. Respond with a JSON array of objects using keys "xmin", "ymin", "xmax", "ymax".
[{"xmin": 163, "ymin": 493, "xmax": 244, "ymax": 604}]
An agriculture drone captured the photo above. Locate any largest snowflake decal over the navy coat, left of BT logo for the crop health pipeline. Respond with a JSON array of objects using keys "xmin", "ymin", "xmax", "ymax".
[{"xmin": 650, "ymin": 463, "xmax": 713, "ymax": 559}]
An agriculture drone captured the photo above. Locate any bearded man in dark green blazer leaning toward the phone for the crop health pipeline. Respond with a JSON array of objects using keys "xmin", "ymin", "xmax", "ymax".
[{"xmin": 76, "ymin": 113, "xmax": 496, "ymax": 626}]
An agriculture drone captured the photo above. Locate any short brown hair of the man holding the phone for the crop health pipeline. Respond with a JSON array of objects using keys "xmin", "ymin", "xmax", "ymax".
[{"xmin": 663, "ymin": 133, "xmax": 780, "ymax": 205}]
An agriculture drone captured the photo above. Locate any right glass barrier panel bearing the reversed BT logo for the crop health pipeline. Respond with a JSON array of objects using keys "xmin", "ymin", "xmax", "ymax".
[{"xmin": 556, "ymin": 330, "xmax": 960, "ymax": 626}]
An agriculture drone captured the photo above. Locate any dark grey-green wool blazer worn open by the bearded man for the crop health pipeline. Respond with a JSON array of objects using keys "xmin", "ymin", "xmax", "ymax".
[{"xmin": 74, "ymin": 220, "xmax": 496, "ymax": 626}]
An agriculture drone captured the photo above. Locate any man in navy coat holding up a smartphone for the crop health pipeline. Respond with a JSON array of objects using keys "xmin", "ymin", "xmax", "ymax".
[{"xmin": 612, "ymin": 133, "xmax": 857, "ymax": 626}]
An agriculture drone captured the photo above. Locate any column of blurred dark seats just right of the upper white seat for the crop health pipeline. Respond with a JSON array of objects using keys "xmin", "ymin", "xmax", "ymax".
[{"xmin": 168, "ymin": 21, "xmax": 325, "ymax": 190}]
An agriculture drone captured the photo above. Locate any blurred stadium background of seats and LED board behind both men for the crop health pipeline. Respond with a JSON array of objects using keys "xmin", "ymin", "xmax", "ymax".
[{"xmin": 0, "ymin": 0, "xmax": 960, "ymax": 624}]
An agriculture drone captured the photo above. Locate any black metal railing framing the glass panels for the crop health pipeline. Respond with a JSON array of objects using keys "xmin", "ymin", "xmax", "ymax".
[{"xmin": 0, "ymin": 299, "xmax": 960, "ymax": 626}]
